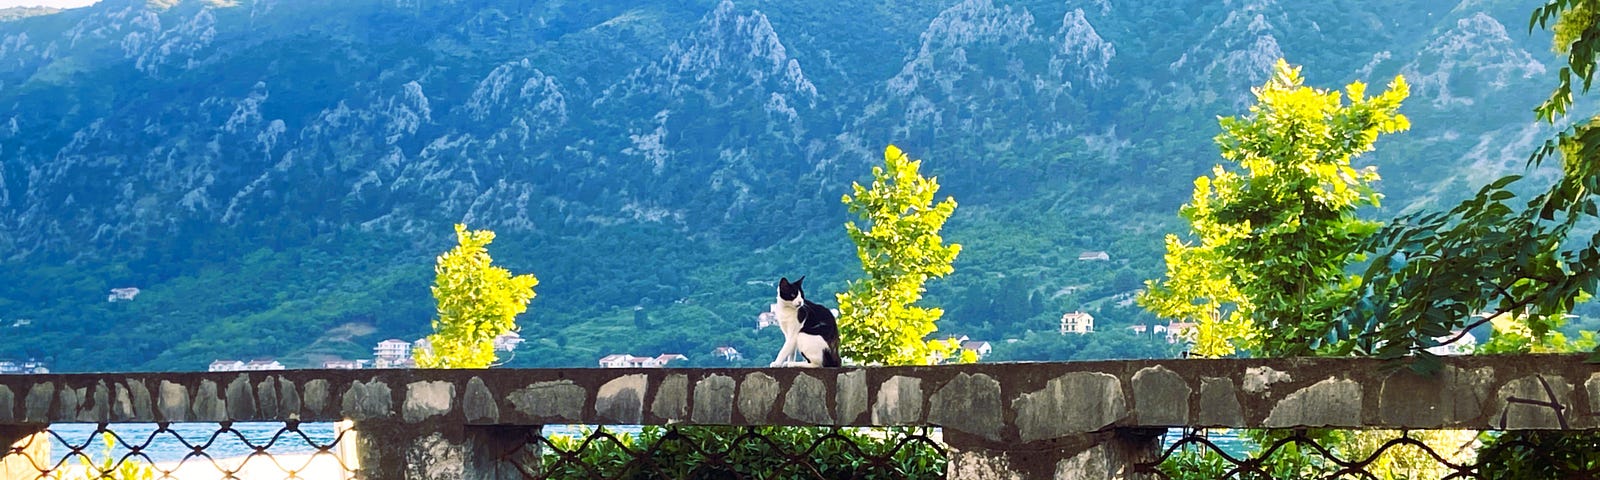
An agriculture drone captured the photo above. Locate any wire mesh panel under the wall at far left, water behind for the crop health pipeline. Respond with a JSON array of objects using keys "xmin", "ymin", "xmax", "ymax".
[{"xmin": 0, "ymin": 421, "xmax": 355, "ymax": 480}]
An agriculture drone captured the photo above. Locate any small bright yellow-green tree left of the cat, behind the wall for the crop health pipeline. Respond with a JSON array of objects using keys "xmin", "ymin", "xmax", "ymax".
[{"xmin": 414, "ymin": 224, "xmax": 539, "ymax": 368}]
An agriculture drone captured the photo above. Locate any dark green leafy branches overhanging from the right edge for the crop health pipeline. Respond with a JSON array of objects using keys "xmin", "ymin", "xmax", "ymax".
[{"xmin": 1330, "ymin": 0, "xmax": 1600, "ymax": 371}]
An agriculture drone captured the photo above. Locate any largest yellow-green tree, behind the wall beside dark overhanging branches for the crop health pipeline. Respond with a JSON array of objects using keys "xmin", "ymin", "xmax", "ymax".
[{"xmin": 1139, "ymin": 59, "xmax": 1410, "ymax": 357}]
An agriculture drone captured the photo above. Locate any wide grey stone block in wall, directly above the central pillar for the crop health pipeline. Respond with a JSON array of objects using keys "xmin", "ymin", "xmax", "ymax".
[{"xmin": 1011, "ymin": 371, "xmax": 1128, "ymax": 442}]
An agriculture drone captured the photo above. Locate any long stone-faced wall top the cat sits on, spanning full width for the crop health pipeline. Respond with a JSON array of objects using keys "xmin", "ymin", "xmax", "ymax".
[{"xmin": 0, "ymin": 355, "xmax": 1600, "ymax": 443}]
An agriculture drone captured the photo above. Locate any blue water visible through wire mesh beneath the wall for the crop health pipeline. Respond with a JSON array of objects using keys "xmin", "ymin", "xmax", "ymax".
[{"xmin": 50, "ymin": 422, "xmax": 1254, "ymax": 464}]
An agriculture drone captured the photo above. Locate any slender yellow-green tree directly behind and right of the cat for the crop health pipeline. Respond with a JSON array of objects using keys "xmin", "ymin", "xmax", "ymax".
[{"xmin": 838, "ymin": 146, "xmax": 962, "ymax": 365}]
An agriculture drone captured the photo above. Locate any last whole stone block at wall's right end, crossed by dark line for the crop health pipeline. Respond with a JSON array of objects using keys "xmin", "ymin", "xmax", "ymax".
[{"xmin": 1488, "ymin": 374, "xmax": 1574, "ymax": 430}]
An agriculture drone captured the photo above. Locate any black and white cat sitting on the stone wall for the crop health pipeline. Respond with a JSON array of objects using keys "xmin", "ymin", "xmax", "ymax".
[{"xmin": 771, "ymin": 277, "xmax": 842, "ymax": 366}]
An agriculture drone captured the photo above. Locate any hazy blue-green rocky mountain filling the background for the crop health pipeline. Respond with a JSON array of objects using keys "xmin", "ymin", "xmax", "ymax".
[{"xmin": 0, "ymin": 0, "xmax": 1557, "ymax": 371}]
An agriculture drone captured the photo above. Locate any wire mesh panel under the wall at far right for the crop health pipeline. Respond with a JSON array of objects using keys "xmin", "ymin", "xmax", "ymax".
[{"xmin": 1136, "ymin": 429, "xmax": 1600, "ymax": 480}]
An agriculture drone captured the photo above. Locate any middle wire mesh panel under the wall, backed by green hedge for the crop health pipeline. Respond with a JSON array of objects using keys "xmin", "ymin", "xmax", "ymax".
[{"xmin": 515, "ymin": 426, "xmax": 946, "ymax": 478}]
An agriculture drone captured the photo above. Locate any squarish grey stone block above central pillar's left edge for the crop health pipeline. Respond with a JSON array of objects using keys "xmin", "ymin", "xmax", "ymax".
[{"xmin": 928, "ymin": 371, "xmax": 1005, "ymax": 442}]
